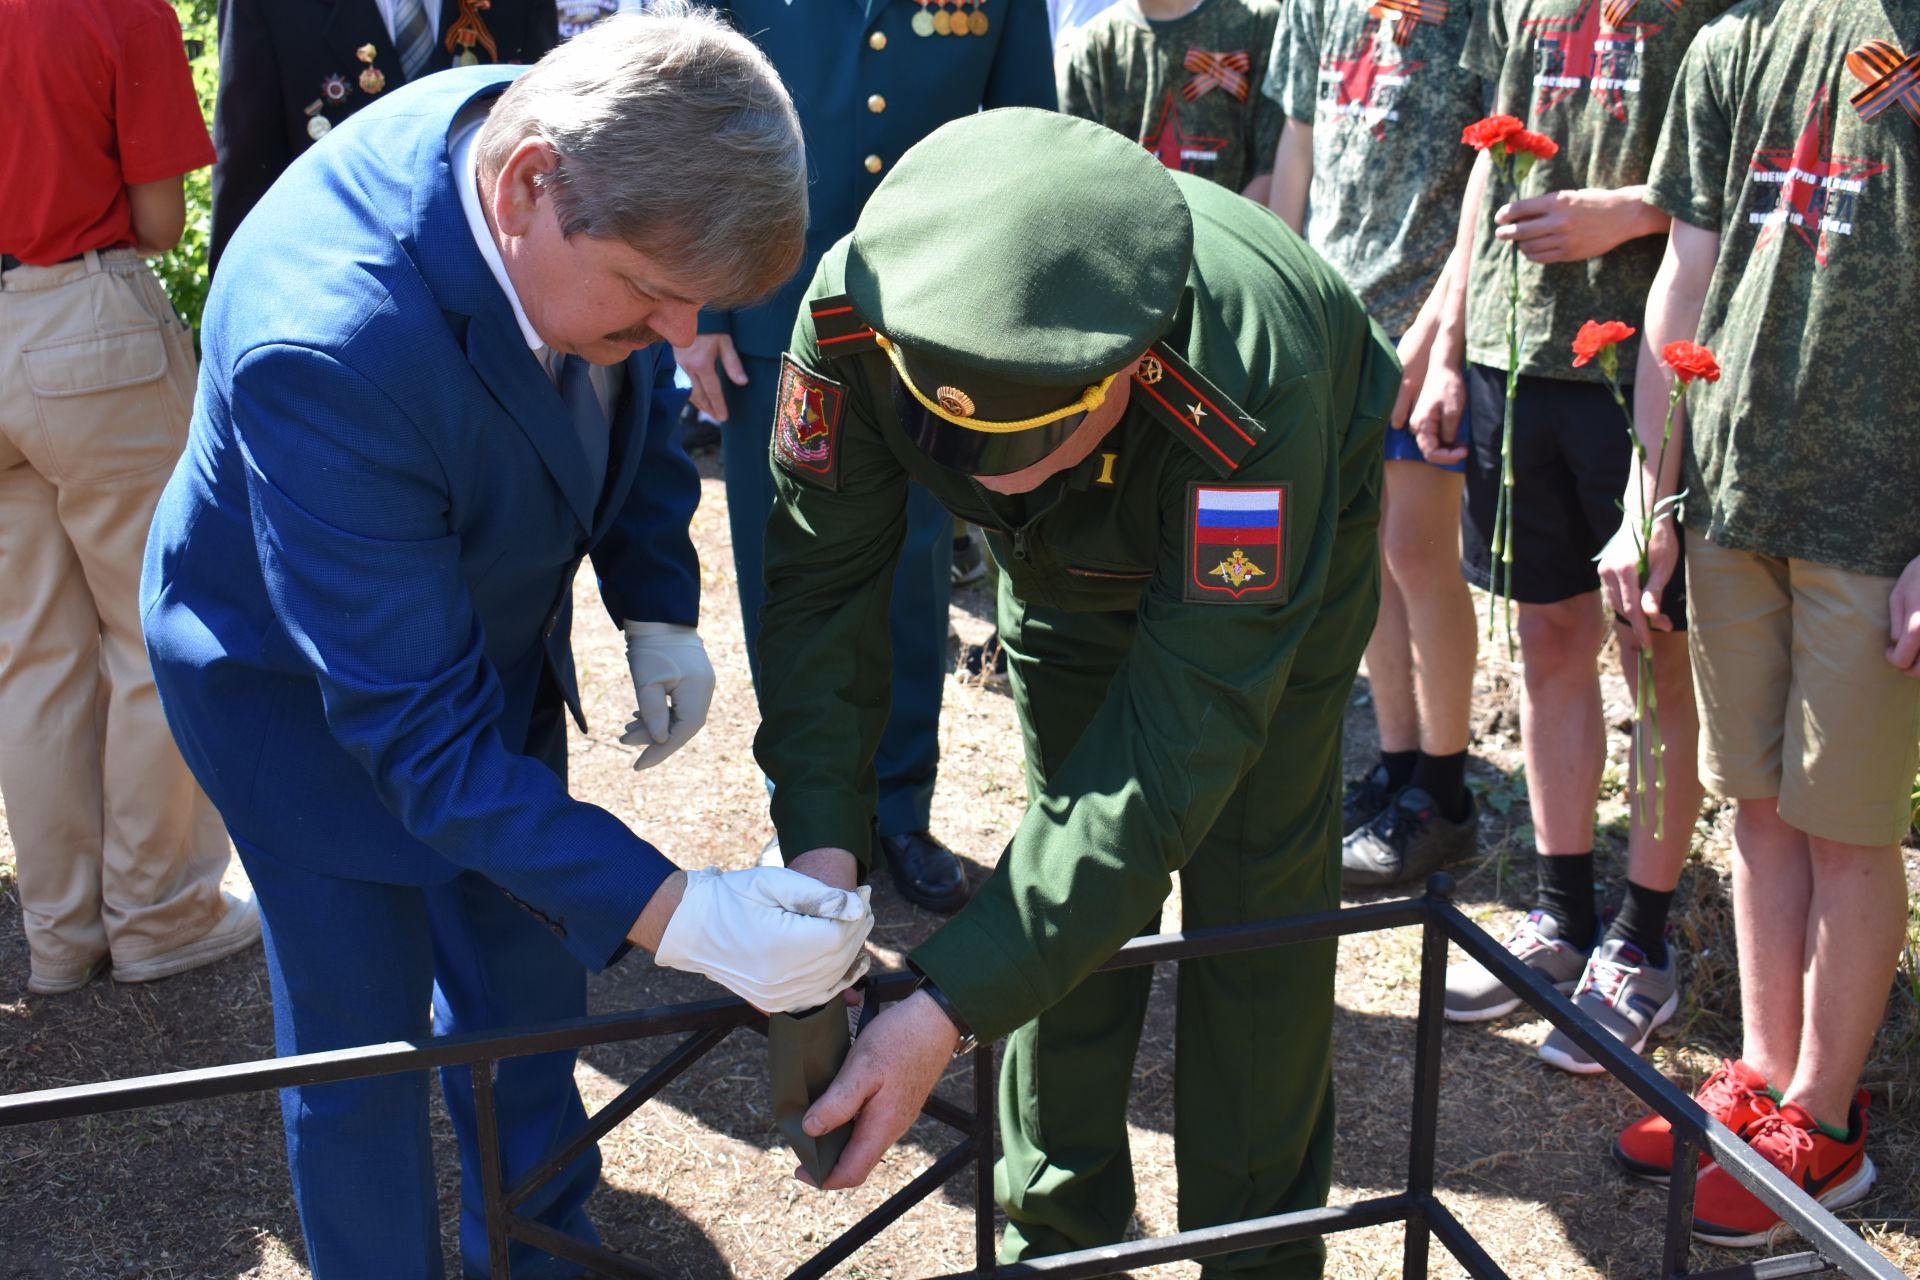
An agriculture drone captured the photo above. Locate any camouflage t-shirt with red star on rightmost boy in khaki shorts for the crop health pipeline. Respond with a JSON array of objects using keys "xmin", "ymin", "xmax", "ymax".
[{"xmin": 1649, "ymin": 0, "xmax": 1920, "ymax": 576}]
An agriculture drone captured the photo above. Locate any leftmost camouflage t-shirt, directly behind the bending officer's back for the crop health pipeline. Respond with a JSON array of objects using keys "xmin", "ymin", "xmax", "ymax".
[{"xmin": 1060, "ymin": 0, "xmax": 1286, "ymax": 192}]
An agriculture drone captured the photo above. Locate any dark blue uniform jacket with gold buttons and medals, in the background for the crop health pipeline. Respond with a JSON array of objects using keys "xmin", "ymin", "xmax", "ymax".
[{"xmin": 701, "ymin": 0, "xmax": 1071, "ymax": 357}]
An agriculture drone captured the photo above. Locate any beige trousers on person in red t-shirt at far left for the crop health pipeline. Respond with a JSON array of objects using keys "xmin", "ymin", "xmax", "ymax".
[{"xmin": 0, "ymin": 249, "xmax": 232, "ymax": 979}]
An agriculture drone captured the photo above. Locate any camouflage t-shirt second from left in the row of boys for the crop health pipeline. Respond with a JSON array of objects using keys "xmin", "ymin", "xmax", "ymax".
[{"xmin": 1265, "ymin": 0, "xmax": 1484, "ymax": 336}]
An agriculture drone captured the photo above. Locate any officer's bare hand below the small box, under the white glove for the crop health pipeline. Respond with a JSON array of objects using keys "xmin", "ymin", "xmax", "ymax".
[{"xmin": 793, "ymin": 992, "xmax": 960, "ymax": 1192}]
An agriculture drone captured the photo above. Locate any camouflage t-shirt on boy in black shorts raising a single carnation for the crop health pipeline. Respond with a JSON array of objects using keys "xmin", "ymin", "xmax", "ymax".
[{"xmin": 1461, "ymin": 0, "xmax": 1734, "ymax": 382}]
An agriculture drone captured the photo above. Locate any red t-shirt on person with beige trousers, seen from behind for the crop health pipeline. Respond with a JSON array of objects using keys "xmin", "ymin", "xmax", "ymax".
[{"xmin": 0, "ymin": 0, "xmax": 213, "ymax": 267}]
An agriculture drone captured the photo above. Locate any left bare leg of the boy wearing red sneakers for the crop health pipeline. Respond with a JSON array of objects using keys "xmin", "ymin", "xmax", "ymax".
[{"xmin": 1734, "ymin": 796, "xmax": 1812, "ymax": 1090}]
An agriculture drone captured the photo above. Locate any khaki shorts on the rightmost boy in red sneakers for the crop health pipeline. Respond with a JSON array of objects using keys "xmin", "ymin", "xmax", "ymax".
[{"xmin": 1686, "ymin": 535, "xmax": 1920, "ymax": 846}]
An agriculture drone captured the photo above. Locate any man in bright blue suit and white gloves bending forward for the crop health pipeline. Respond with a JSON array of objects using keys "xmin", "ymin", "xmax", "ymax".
[{"xmin": 142, "ymin": 13, "xmax": 872, "ymax": 1280}]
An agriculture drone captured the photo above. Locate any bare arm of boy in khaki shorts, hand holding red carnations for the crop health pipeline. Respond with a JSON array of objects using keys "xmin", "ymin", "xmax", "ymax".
[{"xmin": 1599, "ymin": 219, "xmax": 1720, "ymax": 647}]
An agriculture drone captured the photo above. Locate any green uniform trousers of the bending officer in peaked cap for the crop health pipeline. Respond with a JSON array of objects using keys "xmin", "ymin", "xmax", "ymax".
[{"xmin": 995, "ymin": 475, "xmax": 1379, "ymax": 1280}]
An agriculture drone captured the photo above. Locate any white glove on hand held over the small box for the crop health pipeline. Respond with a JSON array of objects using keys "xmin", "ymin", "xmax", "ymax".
[{"xmin": 653, "ymin": 867, "xmax": 874, "ymax": 1013}]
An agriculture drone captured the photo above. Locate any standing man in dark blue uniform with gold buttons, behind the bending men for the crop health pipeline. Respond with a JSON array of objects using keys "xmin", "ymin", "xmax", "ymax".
[{"xmin": 676, "ymin": 0, "xmax": 1071, "ymax": 912}]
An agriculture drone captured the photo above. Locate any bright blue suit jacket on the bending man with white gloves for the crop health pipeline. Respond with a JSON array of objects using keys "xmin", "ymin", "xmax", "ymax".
[{"xmin": 142, "ymin": 67, "xmax": 699, "ymax": 967}]
